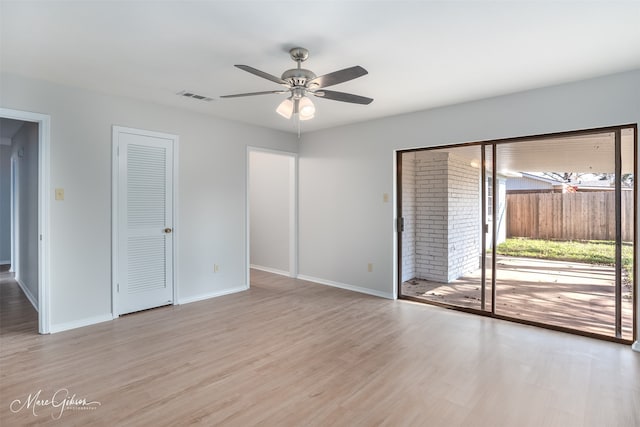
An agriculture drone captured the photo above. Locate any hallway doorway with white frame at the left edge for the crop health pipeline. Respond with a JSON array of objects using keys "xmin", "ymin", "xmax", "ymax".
[{"xmin": 0, "ymin": 108, "xmax": 50, "ymax": 334}]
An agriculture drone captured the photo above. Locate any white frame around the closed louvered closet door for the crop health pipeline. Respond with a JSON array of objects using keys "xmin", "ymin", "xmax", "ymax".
[{"xmin": 111, "ymin": 125, "xmax": 180, "ymax": 319}]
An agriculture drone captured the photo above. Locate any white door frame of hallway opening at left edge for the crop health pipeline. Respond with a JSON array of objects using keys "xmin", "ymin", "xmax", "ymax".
[{"xmin": 0, "ymin": 108, "xmax": 51, "ymax": 334}]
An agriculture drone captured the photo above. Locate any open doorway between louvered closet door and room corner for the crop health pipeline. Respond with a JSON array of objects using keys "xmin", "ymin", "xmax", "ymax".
[{"xmin": 247, "ymin": 147, "xmax": 298, "ymax": 284}]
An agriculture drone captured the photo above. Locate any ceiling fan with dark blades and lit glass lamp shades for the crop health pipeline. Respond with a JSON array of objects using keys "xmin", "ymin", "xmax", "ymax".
[{"xmin": 220, "ymin": 47, "xmax": 373, "ymax": 120}]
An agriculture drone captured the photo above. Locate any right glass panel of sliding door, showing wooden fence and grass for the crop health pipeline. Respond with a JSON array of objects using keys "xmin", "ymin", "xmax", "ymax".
[{"xmin": 495, "ymin": 132, "xmax": 633, "ymax": 339}]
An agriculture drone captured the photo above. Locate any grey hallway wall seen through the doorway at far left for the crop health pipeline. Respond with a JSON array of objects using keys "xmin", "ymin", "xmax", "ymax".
[{"xmin": 11, "ymin": 122, "xmax": 39, "ymax": 307}]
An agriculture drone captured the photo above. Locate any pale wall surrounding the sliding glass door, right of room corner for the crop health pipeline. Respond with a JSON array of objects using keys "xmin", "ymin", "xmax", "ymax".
[{"xmin": 299, "ymin": 70, "xmax": 640, "ymax": 329}]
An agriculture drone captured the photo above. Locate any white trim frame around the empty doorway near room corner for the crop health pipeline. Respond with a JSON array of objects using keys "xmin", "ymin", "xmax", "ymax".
[{"xmin": 245, "ymin": 146, "xmax": 298, "ymax": 289}]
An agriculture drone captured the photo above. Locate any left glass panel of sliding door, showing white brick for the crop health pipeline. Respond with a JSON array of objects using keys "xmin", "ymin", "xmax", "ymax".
[{"xmin": 400, "ymin": 146, "xmax": 487, "ymax": 310}]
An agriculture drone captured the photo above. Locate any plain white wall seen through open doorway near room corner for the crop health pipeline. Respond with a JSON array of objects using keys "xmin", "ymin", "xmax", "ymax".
[{"xmin": 249, "ymin": 151, "xmax": 295, "ymax": 274}]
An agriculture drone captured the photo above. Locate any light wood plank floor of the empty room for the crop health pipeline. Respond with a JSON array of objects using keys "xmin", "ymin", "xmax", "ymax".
[{"xmin": 0, "ymin": 271, "xmax": 640, "ymax": 427}]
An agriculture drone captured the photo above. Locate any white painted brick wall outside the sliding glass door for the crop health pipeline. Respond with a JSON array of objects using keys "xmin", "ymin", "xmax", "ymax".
[{"xmin": 402, "ymin": 151, "xmax": 480, "ymax": 283}]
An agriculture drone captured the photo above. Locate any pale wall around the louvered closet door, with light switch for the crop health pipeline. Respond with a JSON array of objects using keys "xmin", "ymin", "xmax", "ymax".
[{"xmin": 0, "ymin": 74, "xmax": 297, "ymax": 330}]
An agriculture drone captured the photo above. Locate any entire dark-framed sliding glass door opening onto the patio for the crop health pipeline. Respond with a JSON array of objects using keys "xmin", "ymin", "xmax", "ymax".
[{"xmin": 397, "ymin": 125, "xmax": 637, "ymax": 343}]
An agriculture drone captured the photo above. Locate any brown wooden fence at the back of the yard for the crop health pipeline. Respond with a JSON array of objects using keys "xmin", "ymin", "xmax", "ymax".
[{"xmin": 506, "ymin": 190, "xmax": 633, "ymax": 241}]
